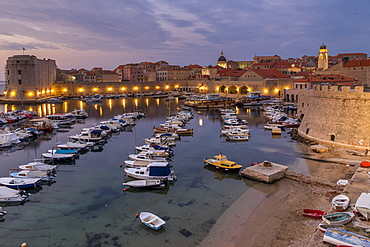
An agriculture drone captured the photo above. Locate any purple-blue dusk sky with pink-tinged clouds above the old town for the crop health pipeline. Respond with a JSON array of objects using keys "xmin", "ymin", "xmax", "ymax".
[{"xmin": 0, "ymin": 0, "xmax": 370, "ymax": 80}]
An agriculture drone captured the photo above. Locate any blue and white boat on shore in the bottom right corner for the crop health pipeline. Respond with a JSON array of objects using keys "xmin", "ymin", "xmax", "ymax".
[{"xmin": 323, "ymin": 228, "xmax": 370, "ymax": 247}]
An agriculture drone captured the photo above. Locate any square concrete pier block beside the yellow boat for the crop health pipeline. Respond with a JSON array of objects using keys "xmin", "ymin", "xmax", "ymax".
[{"xmin": 241, "ymin": 161, "xmax": 288, "ymax": 183}]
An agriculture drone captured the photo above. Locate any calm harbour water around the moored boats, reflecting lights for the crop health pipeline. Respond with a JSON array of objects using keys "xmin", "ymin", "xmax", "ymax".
[{"xmin": 0, "ymin": 98, "xmax": 310, "ymax": 247}]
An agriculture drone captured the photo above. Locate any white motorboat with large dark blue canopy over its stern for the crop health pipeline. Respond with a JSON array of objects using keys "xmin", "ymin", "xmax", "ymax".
[{"xmin": 124, "ymin": 162, "xmax": 176, "ymax": 181}]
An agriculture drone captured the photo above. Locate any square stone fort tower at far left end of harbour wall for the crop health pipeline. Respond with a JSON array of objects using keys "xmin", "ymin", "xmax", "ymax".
[{"xmin": 5, "ymin": 55, "xmax": 56, "ymax": 101}]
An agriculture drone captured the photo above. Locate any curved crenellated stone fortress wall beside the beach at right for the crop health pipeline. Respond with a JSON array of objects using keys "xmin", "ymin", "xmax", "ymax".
[{"xmin": 298, "ymin": 86, "xmax": 370, "ymax": 150}]
